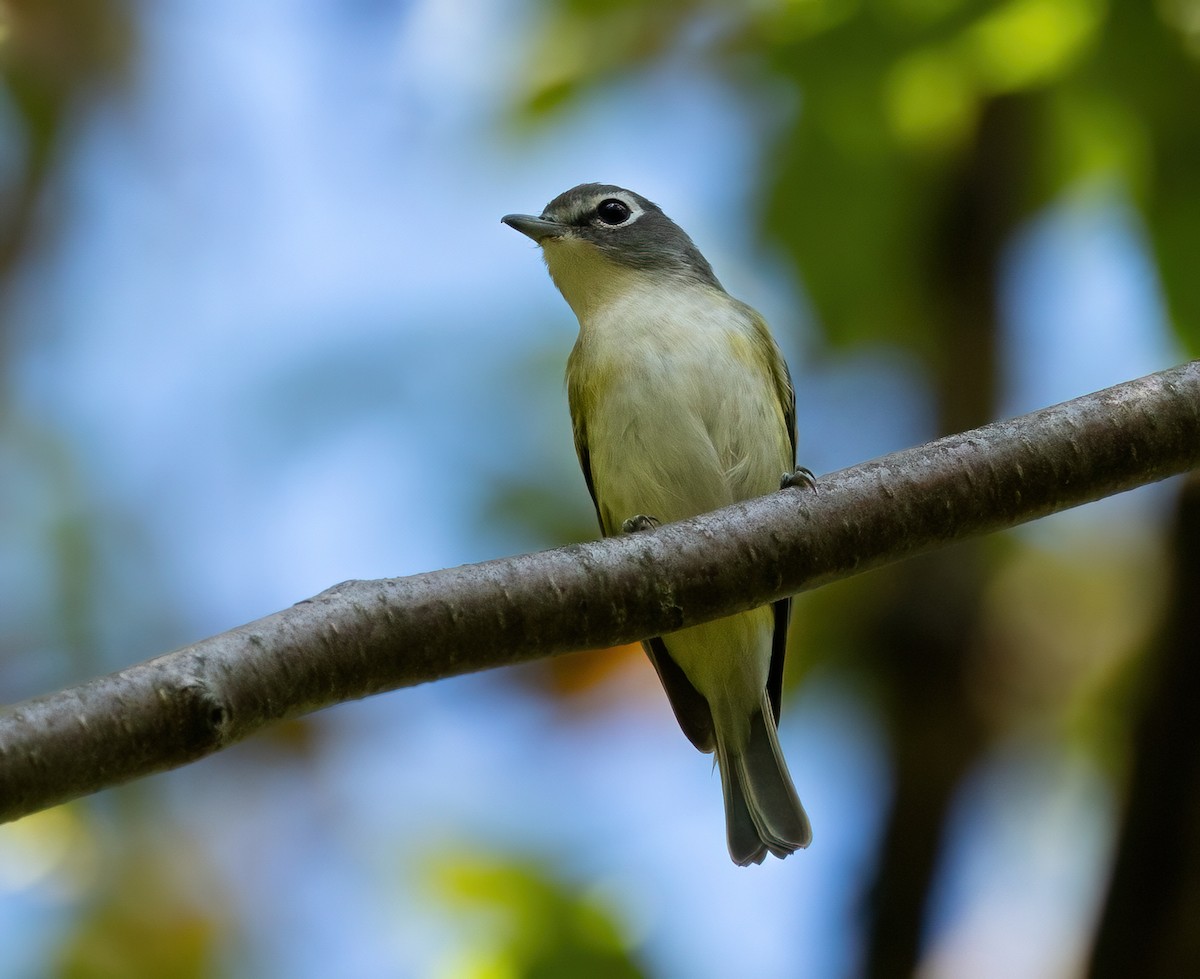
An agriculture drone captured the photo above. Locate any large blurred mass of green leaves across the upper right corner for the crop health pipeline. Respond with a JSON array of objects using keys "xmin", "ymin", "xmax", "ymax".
[{"xmin": 513, "ymin": 0, "xmax": 1200, "ymax": 359}]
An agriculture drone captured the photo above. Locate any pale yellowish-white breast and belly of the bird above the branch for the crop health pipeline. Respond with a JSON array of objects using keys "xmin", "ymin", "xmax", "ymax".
[{"xmin": 568, "ymin": 274, "xmax": 791, "ymax": 533}]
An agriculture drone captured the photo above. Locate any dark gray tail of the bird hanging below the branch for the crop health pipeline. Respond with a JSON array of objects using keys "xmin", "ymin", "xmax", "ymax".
[{"xmin": 716, "ymin": 691, "xmax": 812, "ymax": 866}]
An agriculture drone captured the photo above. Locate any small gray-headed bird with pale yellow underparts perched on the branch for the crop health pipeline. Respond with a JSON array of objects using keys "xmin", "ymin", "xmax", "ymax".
[{"xmin": 502, "ymin": 184, "xmax": 816, "ymax": 866}]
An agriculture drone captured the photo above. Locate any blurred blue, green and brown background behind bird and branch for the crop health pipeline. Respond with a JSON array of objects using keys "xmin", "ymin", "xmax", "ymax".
[{"xmin": 0, "ymin": 0, "xmax": 1200, "ymax": 979}]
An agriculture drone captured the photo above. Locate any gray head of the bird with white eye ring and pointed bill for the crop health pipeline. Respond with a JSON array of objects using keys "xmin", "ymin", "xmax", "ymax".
[{"xmin": 502, "ymin": 184, "xmax": 720, "ymax": 292}]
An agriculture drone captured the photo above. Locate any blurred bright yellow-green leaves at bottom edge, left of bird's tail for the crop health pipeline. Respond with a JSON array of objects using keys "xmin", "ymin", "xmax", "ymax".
[{"xmin": 431, "ymin": 854, "xmax": 646, "ymax": 979}]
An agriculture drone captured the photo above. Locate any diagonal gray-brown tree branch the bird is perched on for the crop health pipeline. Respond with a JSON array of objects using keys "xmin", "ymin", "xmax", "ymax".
[{"xmin": 0, "ymin": 361, "xmax": 1200, "ymax": 821}]
